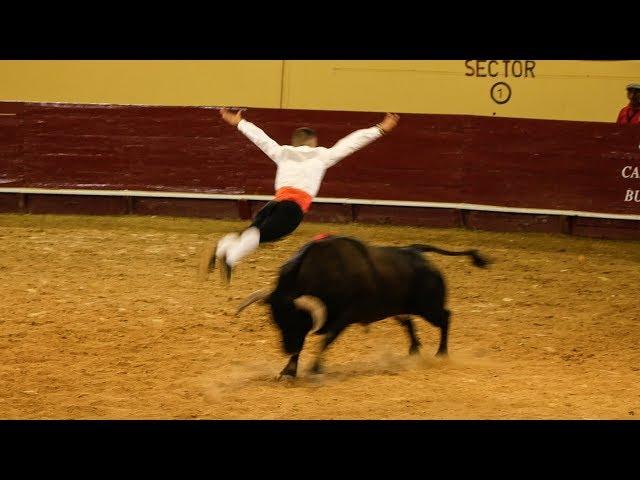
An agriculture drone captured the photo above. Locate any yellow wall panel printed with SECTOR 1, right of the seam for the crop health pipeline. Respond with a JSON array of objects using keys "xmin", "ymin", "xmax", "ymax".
[{"xmin": 283, "ymin": 59, "xmax": 640, "ymax": 122}]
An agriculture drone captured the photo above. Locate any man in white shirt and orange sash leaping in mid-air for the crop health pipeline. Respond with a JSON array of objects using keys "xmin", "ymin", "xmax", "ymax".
[{"xmin": 200, "ymin": 108, "xmax": 400, "ymax": 282}]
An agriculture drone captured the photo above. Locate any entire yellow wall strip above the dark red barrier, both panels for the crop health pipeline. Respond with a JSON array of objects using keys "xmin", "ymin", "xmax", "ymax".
[{"xmin": 0, "ymin": 59, "xmax": 640, "ymax": 122}]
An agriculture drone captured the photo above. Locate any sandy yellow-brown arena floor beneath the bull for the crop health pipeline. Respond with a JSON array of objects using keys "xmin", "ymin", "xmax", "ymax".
[{"xmin": 0, "ymin": 215, "xmax": 640, "ymax": 419}]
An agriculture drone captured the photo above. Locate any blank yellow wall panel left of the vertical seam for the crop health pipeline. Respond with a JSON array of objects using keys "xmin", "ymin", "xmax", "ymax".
[{"xmin": 0, "ymin": 60, "xmax": 282, "ymax": 108}]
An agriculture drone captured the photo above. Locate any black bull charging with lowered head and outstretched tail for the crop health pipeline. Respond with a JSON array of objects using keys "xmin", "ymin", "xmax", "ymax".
[{"xmin": 237, "ymin": 237, "xmax": 487, "ymax": 377}]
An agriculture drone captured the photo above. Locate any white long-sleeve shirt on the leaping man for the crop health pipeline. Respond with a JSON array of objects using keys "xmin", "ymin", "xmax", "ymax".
[{"xmin": 238, "ymin": 120, "xmax": 382, "ymax": 197}]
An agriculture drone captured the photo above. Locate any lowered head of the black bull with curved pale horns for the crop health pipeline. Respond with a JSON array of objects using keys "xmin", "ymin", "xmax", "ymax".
[{"xmin": 236, "ymin": 289, "xmax": 327, "ymax": 353}]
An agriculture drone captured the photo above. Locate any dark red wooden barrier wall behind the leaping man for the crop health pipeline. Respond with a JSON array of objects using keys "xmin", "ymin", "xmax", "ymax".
[{"xmin": 0, "ymin": 103, "xmax": 640, "ymax": 238}]
